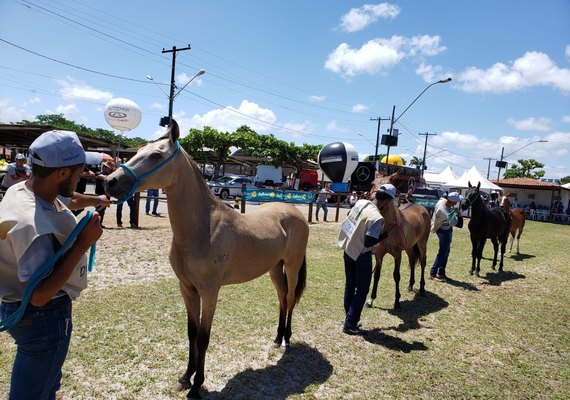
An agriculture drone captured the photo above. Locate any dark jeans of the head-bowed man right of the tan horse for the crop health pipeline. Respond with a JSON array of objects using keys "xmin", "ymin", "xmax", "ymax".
[{"xmin": 344, "ymin": 251, "xmax": 372, "ymax": 328}]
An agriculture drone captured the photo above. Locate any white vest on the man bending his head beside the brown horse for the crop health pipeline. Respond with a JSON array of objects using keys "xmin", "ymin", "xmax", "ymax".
[{"xmin": 338, "ymin": 200, "xmax": 382, "ymax": 260}]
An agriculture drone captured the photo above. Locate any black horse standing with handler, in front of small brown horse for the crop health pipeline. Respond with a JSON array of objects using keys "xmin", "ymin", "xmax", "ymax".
[{"xmin": 462, "ymin": 182, "xmax": 511, "ymax": 276}]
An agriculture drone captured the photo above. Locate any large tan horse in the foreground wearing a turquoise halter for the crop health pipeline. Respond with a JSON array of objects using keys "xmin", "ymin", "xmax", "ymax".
[{"xmin": 105, "ymin": 121, "xmax": 309, "ymax": 398}]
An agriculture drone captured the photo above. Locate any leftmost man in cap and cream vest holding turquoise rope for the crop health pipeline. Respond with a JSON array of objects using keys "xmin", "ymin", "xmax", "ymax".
[{"xmin": 0, "ymin": 131, "xmax": 108, "ymax": 399}]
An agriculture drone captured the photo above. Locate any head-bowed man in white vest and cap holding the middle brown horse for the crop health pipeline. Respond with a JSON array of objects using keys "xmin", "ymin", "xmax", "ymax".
[{"xmin": 338, "ymin": 184, "xmax": 397, "ymax": 335}]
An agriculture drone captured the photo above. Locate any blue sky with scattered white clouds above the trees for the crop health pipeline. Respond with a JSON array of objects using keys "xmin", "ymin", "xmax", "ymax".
[{"xmin": 0, "ymin": 0, "xmax": 570, "ymax": 178}]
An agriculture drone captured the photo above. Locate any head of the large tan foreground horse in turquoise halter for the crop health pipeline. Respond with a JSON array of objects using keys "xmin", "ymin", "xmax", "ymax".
[{"xmin": 105, "ymin": 120, "xmax": 180, "ymax": 200}]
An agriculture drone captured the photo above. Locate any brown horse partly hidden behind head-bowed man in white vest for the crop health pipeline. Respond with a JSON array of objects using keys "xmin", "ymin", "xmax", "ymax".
[{"xmin": 368, "ymin": 178, "xmax": 431, "ymax": 308}]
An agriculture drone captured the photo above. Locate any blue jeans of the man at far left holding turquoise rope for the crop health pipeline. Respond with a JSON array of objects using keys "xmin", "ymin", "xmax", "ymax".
[{"xmin": 0, "ymin": 295, "xmax": 73, "ymax": 400}]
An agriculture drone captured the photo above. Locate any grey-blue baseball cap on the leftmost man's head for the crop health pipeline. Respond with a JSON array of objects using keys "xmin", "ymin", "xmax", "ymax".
[{"xmin": 30, "ymin": 130, "xmax": 85, "ymax": 168}]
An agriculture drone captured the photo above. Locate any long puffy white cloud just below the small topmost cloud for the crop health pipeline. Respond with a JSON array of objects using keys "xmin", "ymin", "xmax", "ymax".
[{"xmin": 325, "ymin": 35, "xmax": 446, "ymax": 77}]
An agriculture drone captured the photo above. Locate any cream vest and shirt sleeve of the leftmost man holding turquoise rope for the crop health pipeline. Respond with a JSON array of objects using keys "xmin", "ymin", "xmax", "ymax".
[{"xmin": 0, "ymin": 182, "xmax": 87, "ymax": 301}]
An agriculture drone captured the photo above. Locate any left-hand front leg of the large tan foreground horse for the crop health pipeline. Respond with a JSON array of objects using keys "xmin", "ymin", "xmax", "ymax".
[{"xmin": 175, "ymin": 282, "xmax": 200, "ymax": 391}]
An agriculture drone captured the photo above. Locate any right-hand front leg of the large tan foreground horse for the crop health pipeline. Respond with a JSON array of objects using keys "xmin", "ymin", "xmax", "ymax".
[{"xmin": 186, "ymin": 284, "xmax": 220, "ymax": 399}]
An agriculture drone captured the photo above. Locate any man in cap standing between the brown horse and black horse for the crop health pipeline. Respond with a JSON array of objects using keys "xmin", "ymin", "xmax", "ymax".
[{"xmin": 429, "ymin": 192, "xmax": 463, "ymax": 282}]
